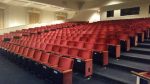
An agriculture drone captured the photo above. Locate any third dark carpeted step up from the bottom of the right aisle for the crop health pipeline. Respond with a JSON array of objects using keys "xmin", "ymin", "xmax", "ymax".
[{"xmin": 121, "ymin": 52, "xmax": 150, "ymax": 64}]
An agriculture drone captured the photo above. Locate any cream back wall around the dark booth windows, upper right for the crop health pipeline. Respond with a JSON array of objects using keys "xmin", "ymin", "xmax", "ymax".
[{"xmin": 100, "ymin": 1, "xmax": 150, "ymax": 20}]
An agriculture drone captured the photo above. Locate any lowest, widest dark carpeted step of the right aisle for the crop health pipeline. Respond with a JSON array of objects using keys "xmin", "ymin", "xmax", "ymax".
[{"xmin": 94, "ymin": 65, "xmax": 136, "ymax": 84}]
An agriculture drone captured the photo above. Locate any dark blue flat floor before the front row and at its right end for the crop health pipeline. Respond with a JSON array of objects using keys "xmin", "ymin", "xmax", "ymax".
[{"xmin": 0, "ymin": 55, "xmax": 113, "ymax": 84}]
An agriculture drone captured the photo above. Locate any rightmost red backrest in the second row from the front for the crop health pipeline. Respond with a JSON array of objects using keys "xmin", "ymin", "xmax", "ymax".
[{"xmin": 79, "ymin": 50, "xmax": 92, "ymax": 60}]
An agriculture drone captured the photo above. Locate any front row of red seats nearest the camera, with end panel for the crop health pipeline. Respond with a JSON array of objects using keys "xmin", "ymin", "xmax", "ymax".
[{"xmin": 0, "ymin": 43, "xmax": 73, "ymax": 84}]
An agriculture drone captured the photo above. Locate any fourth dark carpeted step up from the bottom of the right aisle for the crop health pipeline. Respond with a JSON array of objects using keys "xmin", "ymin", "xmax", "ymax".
[{"xmin": 129, "ymin": 47, "xmax": 150, "ymax": 55}]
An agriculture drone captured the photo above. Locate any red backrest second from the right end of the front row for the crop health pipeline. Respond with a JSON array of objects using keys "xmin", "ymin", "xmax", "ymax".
[{"xmin": 48, "ymin": 54, "xmax": 60, "ymax": 66}]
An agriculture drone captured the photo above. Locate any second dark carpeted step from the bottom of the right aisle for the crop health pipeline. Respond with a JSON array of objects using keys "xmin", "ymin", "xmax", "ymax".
[{"xmin": 109, "ymin": 58, "xmax": 150, "ymax": 71}]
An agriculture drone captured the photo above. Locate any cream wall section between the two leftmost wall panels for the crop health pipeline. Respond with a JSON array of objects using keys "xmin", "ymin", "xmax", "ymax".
[{"xmin": 4, "ymin": 6, "xmax": 27, "ymax": 28}]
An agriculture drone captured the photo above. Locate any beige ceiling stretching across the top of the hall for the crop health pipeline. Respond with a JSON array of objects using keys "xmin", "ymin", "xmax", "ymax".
[{"xmin": 0, "ymin": 0, "xmax": 144, "ymax": 11}]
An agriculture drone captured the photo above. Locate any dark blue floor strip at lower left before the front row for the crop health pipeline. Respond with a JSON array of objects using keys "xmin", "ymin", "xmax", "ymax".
[{"xmin": 0, "ymin": 55, "xmax": 49, "ymax": 84}]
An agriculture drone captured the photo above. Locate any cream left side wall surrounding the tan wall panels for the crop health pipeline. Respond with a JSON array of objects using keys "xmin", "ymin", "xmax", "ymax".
[{"xmin": 0, "ymin": 3, "xmax": 73, "ymax": 35}]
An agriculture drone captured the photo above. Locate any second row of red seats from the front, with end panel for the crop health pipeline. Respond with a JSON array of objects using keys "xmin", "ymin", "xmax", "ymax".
[{"xmin": 4, "ymin": 41, "xmax": 94, "ymax": 77}]
